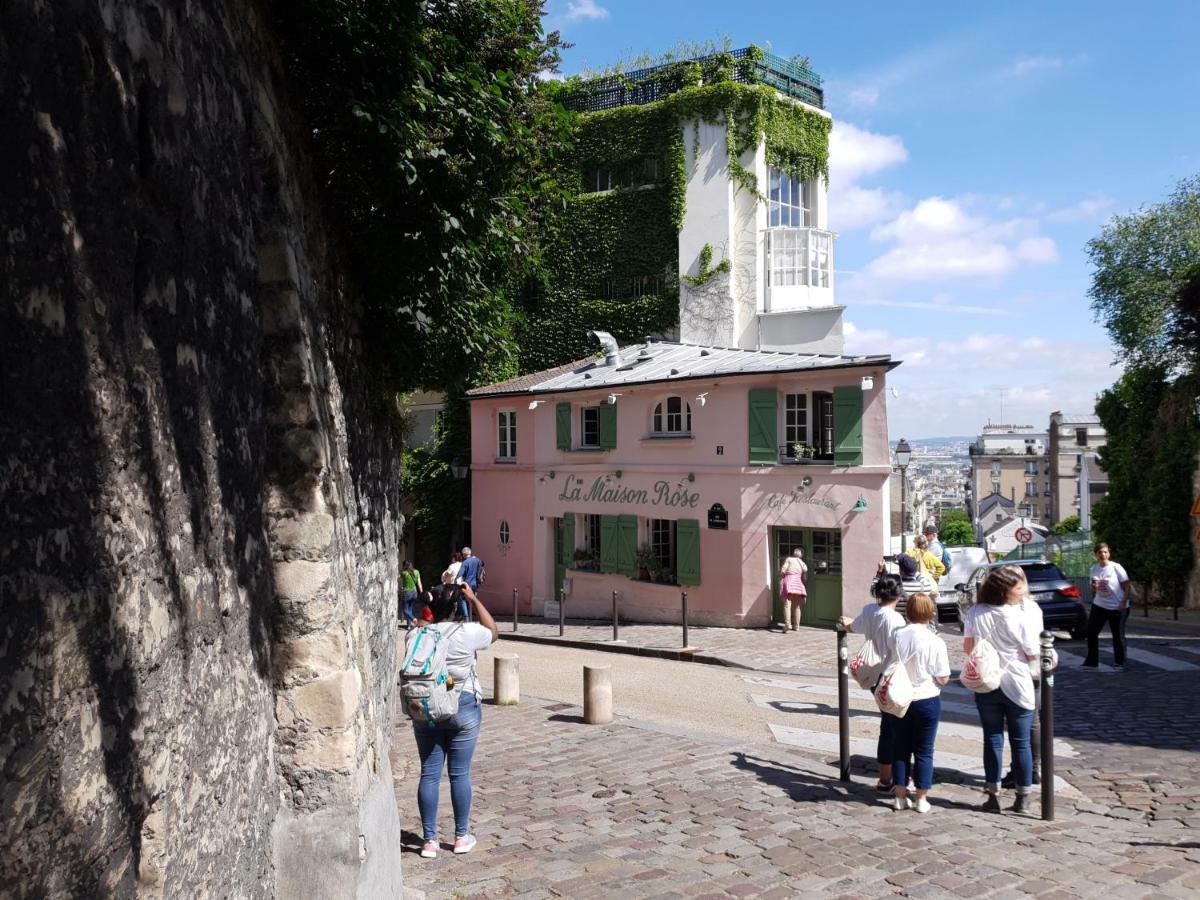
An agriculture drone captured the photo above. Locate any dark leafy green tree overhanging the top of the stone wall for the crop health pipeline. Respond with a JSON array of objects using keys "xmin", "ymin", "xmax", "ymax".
[{"xmin": 274, "ymin": 0, "xmax": 570, "ymax": 392}]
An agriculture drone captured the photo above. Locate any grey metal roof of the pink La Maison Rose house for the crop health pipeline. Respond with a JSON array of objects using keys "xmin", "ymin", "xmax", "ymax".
[{"xmin": 467, "ymin": 341, "xmax": 900, "ymax": 397}]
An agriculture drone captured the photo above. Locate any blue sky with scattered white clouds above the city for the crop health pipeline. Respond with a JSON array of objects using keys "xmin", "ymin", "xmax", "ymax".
[{"xmin": 546, "ymin": 0, "xmax": 1200, "ymax": 438}]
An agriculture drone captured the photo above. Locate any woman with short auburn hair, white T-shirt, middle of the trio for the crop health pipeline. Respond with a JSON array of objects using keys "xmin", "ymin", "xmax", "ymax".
[{"xmin": 892, "ymin": 594, "xmax": 950, "ymax": 812}]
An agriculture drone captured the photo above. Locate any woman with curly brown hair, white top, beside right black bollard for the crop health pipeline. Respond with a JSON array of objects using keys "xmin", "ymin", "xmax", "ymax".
[{"xmin": 962, "ymin": 565, "xmax": 1040, "ymax": 812}]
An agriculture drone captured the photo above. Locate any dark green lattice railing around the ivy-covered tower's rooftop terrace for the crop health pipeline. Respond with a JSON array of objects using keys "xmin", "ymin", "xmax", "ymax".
[{"xmin": 563, "ymin": 47, "xmax": 824, "ymax": 113}]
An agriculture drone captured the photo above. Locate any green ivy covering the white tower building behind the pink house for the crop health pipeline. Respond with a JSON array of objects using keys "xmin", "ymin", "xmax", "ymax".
[{"xmin": 517, "ymin": 55, "xmax": 830, "ymax": 372}]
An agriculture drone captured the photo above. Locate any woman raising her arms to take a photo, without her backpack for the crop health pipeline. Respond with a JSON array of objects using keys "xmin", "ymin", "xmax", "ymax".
[{"xmin": 402, "ymin": 584, "xmax": 500, "ymax": 859}]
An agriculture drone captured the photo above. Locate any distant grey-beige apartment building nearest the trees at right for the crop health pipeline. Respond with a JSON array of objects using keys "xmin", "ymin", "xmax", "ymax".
[{"xmin": 1046, "ymin": 410, "xmax": 1109, "ymax": 528}]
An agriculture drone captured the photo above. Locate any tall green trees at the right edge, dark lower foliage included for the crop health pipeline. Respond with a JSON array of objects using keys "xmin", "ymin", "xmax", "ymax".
[{"xmin": 1088, "ymin": 178, "xmax": 1200, "ymax": 602}]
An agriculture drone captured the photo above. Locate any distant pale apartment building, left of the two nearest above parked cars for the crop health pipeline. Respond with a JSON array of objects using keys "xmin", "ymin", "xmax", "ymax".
[{"xmin": 967, "ymin": 424, "xmax": 1051, "ymax": 534}]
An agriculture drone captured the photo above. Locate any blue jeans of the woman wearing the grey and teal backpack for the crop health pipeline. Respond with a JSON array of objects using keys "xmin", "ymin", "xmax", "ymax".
[{"xmin": 413, "ymin": 691, "xmax": 484, "ymax": 841}]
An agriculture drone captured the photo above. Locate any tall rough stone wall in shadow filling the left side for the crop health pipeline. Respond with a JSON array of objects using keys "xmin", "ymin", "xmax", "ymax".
[{"xmin": 0, "ymin": 0, "xmax": 400, "ymax": 898}]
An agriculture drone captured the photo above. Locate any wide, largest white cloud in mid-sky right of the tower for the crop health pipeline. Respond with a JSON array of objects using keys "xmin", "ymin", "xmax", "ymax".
[{"xmin": 856, "ymin": 197, "xmax": 1058, "ymax": 282}]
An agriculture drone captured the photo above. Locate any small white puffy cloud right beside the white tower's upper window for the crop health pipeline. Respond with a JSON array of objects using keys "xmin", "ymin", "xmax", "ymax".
[{"xmin": 829, "ymin": 122, "xmax": 908, "ymax": 232}]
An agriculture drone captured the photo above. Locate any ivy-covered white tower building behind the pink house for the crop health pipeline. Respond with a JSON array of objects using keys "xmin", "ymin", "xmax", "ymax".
[{"xmin": 521, "ymin": 46, "xmax": 842, "ymax": 372}]
